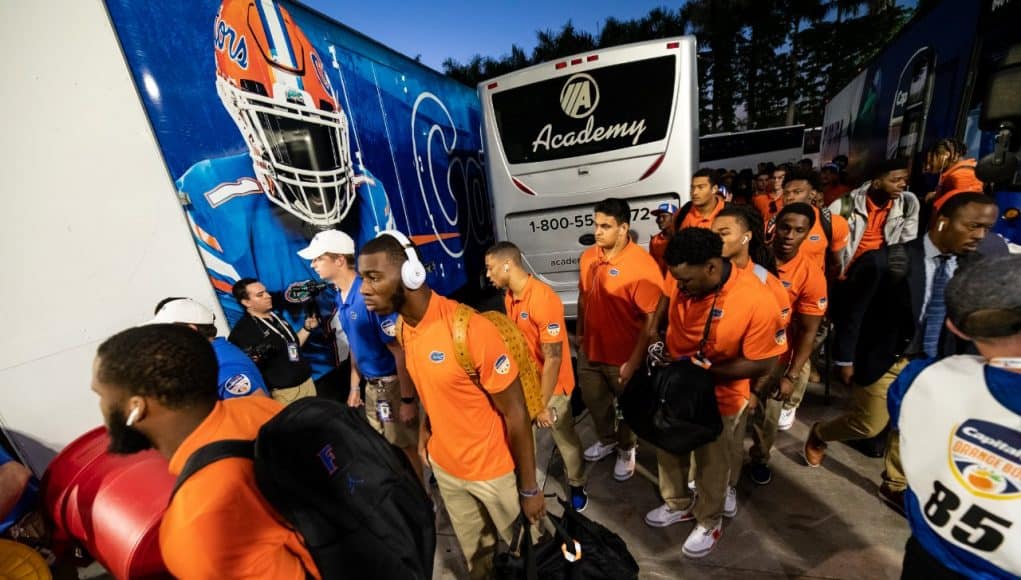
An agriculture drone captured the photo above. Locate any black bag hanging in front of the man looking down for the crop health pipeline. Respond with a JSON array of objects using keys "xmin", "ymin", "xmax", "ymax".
[{"xmin": 618, "ymin": 358, "xmax": 723, "ymax": 455}]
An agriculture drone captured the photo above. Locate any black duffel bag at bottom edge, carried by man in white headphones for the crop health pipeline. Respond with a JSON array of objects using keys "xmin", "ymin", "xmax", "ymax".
[{"xmin": 493, "ymin": 498, "xmax": 638, "ymax": 580}]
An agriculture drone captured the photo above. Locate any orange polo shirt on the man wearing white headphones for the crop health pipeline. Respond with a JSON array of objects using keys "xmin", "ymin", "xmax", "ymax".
[{"xmin": 401, "ymin": 292, "xmax": 518, "ymax": 481}]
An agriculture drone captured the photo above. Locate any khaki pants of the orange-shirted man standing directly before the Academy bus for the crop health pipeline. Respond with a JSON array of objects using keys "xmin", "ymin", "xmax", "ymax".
[{"xmin": 578, "ymin": 350, "xmax": 638, "ymax": 449}]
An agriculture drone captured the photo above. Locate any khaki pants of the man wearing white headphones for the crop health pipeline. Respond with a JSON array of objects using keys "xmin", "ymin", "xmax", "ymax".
[{"xmin": 433, "ymin": 464, "xmax": 521, "ymax": 579}]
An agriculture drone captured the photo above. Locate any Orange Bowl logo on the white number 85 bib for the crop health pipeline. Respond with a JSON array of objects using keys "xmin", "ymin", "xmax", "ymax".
[{"xmin": 947, "ymin": 419, "xmax": 1021, "ymax": 499}]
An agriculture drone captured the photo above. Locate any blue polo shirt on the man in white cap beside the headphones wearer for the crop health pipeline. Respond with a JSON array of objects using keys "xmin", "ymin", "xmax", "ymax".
[{"xmin": 337, "ymin": 277, "xmax": 397, "ymax": 379}]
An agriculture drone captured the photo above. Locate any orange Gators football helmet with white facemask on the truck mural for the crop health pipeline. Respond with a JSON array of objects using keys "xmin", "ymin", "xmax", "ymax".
[{"xmin": 213, "ymin": 0, "xmax": 354, "ymax": 227}]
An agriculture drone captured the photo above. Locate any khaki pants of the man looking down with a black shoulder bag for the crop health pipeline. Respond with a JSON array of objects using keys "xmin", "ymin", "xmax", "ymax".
[{"xmin": 655, "ymin": 408, "xmax": 747, "ymax": 528}]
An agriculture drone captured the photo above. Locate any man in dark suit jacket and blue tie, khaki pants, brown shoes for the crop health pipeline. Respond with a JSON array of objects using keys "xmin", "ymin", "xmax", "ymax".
[{"xmin": 805, "ymin": 193, "xmax": 1007, "ymax": 512}]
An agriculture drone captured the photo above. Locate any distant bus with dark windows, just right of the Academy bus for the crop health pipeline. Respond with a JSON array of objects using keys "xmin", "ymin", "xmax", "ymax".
[{"xmin": 698, "ymin": 125, "xmax": 821, "ymax": 172}]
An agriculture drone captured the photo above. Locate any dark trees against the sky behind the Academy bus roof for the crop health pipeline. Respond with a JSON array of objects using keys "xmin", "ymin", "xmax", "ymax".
[{"xmin": 443, "ymin": 0, "xmax": 924, "ymax": 135}]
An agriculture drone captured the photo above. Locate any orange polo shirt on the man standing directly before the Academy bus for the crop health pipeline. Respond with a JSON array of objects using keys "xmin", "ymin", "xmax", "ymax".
[{"xmin": 578, "ymin": 238, "xmax": 661, "ymax": 366}]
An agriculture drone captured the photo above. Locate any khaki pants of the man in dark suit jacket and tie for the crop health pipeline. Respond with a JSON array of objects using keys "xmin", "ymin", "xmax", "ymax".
[{"xmin": 816, "ymin": 358, "xmax": 909, "ymax": 491}]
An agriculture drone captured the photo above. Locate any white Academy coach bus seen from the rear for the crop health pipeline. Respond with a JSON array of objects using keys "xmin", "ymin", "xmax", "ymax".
[{"xmin": 479, "ymin": 37, "xmax": 698, "ymax": 318}]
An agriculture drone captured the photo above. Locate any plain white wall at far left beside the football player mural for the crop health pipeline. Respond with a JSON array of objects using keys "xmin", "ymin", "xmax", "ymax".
[{"xmin": 0, "ymin": 0, "xmax": 226, "ymax": 473}]
